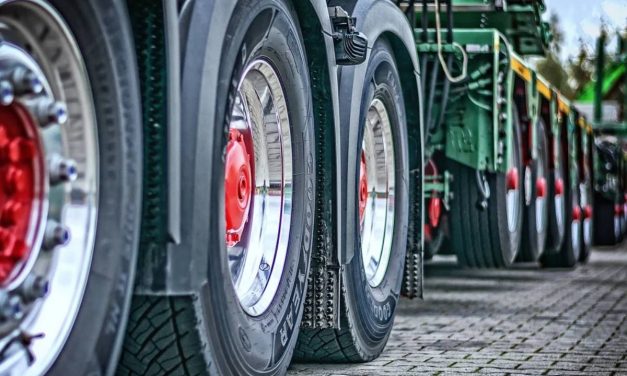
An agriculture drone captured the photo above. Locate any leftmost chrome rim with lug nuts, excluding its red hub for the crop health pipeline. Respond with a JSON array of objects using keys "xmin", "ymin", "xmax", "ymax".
[{"xmin": 0, "ymin": 0, "xmax": 99, "ymax": 374}]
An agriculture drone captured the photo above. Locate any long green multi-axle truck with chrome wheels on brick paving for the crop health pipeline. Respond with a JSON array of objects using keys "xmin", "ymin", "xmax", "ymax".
[{"xmin": 0, "ymin": 0, "xmax": 604, "ymax": 375}]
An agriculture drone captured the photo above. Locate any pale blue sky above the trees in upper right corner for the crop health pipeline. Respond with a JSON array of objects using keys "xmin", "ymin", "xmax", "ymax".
[{"xmin": 544, "ymin": 0, "xmax": 627, "ymax": 60}]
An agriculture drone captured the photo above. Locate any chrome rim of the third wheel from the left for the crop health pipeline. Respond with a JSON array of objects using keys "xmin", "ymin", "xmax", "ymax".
[{"xmin": 359, "ymin": 98, "xmax": 395, "ymax": 287}]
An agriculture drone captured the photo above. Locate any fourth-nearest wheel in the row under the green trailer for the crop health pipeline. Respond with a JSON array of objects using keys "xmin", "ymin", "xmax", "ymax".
[{"xmin": 540, "ymin": 134, "xmax": 581, "ymax": 268}]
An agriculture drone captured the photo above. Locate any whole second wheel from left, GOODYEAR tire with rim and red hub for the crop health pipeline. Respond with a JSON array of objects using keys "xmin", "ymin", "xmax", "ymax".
[{"xmin": 118, "ymin": 0, "xmax": 315, "ymax": 375}]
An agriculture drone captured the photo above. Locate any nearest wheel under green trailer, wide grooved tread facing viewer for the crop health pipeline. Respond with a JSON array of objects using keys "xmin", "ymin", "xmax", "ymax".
[{"xmin": 449, "ymin": 109, "xmax": 524, "ymax": 268}]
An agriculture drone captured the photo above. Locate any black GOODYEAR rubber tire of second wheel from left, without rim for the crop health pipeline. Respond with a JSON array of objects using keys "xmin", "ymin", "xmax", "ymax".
[{"xmin": 118, "ymin": 0, "xmax": 315, "ymax": 375}]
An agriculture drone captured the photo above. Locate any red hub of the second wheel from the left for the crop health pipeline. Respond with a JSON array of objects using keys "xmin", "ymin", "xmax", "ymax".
[{"xmin": 224, "ymin": 129, "xmax": 253, "ymax": 247}]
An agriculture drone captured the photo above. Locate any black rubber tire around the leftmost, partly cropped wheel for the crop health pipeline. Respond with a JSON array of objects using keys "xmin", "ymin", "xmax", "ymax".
[{"xmin": 39, "ymin": 0, "xmax": 142, "ymax": 375}]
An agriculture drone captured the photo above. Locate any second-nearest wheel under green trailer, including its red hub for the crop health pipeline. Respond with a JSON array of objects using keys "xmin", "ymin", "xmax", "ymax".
[{"xmin": 519, "ymin": 119, "xmax": 549, "ymax": 262}]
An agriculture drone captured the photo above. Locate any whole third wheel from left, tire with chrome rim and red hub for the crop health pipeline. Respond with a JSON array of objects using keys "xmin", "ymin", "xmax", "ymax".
[{"xmin": 295, "ymin": 39, "xmax": 409, "ymax": 362}]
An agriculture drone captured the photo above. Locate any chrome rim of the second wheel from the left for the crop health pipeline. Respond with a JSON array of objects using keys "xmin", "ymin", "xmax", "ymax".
[{"xmin": 225, "ymin": 59, "xmax": 293, "ymax": 316}]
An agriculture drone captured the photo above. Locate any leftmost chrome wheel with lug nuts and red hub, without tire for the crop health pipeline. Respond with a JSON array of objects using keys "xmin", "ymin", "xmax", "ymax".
[{"xmin": 0, "ymin": 0, "xmax": 99, "ymax": 373}]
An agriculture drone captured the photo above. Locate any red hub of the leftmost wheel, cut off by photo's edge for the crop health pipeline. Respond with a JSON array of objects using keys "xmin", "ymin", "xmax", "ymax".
[{"xmin": 0, "ymin": 104, "xmax": 43, "ymax": 283}]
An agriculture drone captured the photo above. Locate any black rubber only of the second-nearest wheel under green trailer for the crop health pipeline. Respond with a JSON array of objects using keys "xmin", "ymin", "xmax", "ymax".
[{"xmin": 519, "ymin": 120, "xmax": 549, "ymax": 262}]
